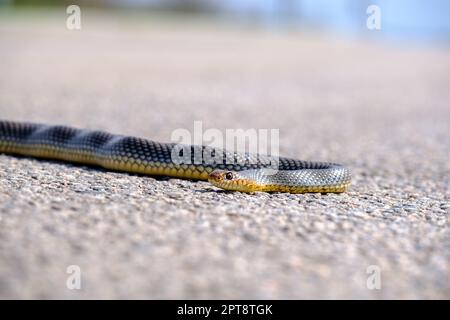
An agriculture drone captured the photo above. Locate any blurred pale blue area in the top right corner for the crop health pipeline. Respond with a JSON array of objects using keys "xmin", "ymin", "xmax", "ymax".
[{"xmin": 222, "ymin": 0, "xmax": 450, "ymax": 42}]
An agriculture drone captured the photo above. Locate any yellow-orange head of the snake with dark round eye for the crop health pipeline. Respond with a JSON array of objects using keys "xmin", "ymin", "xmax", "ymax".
[{"xmin": 208, "ymin": 170, "xmax": 260, "ymax": 192}]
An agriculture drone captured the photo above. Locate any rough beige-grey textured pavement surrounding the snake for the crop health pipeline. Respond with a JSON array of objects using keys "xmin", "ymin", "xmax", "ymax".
[{"xmin": 0, "ymin": 12, "xmax": 450, "ymax": 299}]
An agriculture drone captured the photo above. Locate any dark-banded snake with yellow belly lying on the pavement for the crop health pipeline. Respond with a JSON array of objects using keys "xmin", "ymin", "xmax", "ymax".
[{"xmin": 0, "ymin": 120, "xmax": 351, "ymax": 193}]
